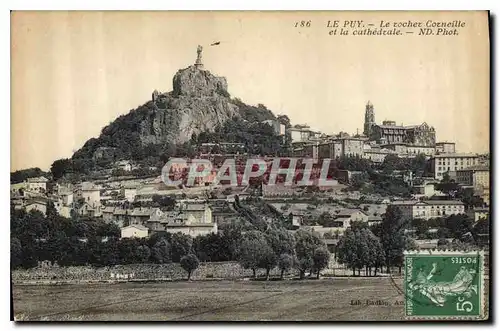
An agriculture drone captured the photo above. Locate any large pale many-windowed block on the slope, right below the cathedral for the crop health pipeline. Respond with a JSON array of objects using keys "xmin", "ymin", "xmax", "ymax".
[{"xmin": 429, "ymin": 153, "xmax": 480, "ymax": 180}]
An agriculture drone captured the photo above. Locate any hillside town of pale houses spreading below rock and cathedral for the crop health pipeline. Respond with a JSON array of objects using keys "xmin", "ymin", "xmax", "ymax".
[{"xmin": 11, "ymin": 102, "xmax": 490, "ymax": 246}]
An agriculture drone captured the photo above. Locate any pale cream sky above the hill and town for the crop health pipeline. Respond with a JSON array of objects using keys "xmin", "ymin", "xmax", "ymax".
[{"xmin": 11, "ymin": 11, "xmax": 490, "ymax": 171}]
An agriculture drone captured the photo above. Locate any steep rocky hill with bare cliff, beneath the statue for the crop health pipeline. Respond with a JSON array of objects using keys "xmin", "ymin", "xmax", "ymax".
[{"xmin": 73, "ymin": 64, "xmax": 276, "ymax": 165}]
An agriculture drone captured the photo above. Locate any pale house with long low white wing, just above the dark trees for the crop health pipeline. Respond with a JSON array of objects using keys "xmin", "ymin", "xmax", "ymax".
[{"xmin": 147, "ymin": 203, "xmax": 217, "ymax": 237}]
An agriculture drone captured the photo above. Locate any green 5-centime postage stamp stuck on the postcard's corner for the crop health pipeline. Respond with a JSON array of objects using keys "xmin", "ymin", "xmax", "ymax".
[{"xmin": 404, "ymin": 250, "xmax": 486, "ymax": 320}]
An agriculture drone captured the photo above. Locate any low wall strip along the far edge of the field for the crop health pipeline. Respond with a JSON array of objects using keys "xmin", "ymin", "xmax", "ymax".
[{"xmin": 12, "ymin": 262, "xmax": 296, "ymax": 283}]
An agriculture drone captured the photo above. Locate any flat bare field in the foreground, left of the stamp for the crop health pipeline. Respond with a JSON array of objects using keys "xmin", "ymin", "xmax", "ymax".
[{"xmin": 13, "ymin": 278, "xmax": 410, "ymax": 321}]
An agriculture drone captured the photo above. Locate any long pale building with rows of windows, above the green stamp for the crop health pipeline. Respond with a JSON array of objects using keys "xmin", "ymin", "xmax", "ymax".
[{"xmin": 392, "ymin": 200, "xmax": 465, "ymax": 220}]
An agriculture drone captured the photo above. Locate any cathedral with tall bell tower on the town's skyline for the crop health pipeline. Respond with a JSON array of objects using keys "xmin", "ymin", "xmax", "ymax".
[{"xmin": 363, "ymin": 101, "xmax": 436, "ymax": 147}]
